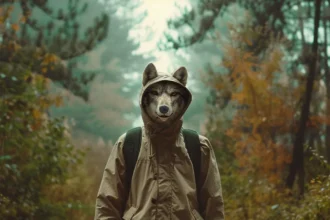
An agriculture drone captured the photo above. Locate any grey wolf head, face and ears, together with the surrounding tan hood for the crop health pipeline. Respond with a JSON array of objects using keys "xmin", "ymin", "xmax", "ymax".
[{"xmin": 140, "ymin": 63, "xmax": 192, "ymax": 137}]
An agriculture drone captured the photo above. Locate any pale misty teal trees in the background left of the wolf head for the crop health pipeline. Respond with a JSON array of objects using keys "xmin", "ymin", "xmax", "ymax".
[{"xmin": 51, "ymin": 0, "xmax": 152, "ymax": 142}]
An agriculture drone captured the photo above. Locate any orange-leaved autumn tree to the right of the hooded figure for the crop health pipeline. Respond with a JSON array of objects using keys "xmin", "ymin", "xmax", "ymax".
[{"xmin": 210, "ymin": 22, "xmax": 294, "ymax": 183}]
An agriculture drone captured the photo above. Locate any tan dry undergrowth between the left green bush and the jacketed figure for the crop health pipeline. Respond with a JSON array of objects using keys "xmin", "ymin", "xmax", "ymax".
[{"xmin": 41, "ymin": 144, "xmax": 110, "ymax": 220}]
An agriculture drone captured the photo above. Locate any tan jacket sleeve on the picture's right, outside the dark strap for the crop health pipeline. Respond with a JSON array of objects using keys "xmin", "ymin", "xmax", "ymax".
[{"xmin": 199, "ymin": 136, "xmax": 225, "ymax": 220}]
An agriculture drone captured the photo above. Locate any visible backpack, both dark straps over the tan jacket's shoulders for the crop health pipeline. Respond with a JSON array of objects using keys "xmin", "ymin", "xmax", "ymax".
[{"xmin": 123, "ymin": 127, "xmax": 201, "ymax": 192}]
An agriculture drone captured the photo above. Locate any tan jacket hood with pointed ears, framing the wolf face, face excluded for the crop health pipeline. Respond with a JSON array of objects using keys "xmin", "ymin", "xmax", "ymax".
[{"xmin": 139, "ymin": 63, "xmax": 192, "ymax": 139}]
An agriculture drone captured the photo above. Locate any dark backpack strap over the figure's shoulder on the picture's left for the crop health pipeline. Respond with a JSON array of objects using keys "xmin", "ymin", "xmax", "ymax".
[{"xmin": 123, "ymin": 127, "xmax": 142, "ymax": 192}]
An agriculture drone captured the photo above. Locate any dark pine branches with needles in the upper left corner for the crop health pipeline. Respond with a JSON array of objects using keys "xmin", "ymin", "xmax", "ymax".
[{"xmin": 0, "ymin": 0, "xmax": 109, "ymax": 100}]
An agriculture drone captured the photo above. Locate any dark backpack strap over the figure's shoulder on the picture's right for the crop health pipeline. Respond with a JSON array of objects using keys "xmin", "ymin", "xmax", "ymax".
[{"xmin": 182, "ymin": 129, "xmax": 201, "ymax": 190}]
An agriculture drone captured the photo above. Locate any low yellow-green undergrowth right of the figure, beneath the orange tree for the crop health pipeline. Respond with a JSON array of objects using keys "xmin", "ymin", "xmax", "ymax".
[{"xmin": 207, "ymin": 120, "xmax": 330, "ymax": 220}]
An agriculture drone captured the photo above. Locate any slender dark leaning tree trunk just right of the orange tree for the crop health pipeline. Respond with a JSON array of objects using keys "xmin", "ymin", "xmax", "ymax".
[{"xmin": 286, "ymin": 0, "xmax": 321, "ymax": 196}]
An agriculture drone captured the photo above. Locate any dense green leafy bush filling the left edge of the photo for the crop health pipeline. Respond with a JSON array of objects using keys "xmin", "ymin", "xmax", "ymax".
[{"xmin": 0, "ymin": 45, "xmax": 83, "ymax": 219}]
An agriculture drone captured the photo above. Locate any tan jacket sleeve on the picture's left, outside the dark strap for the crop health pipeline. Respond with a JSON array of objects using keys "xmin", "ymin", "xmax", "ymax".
[{"xmin": 95, "ymin": 135, "xmax": 127, "ymax": 220}]
